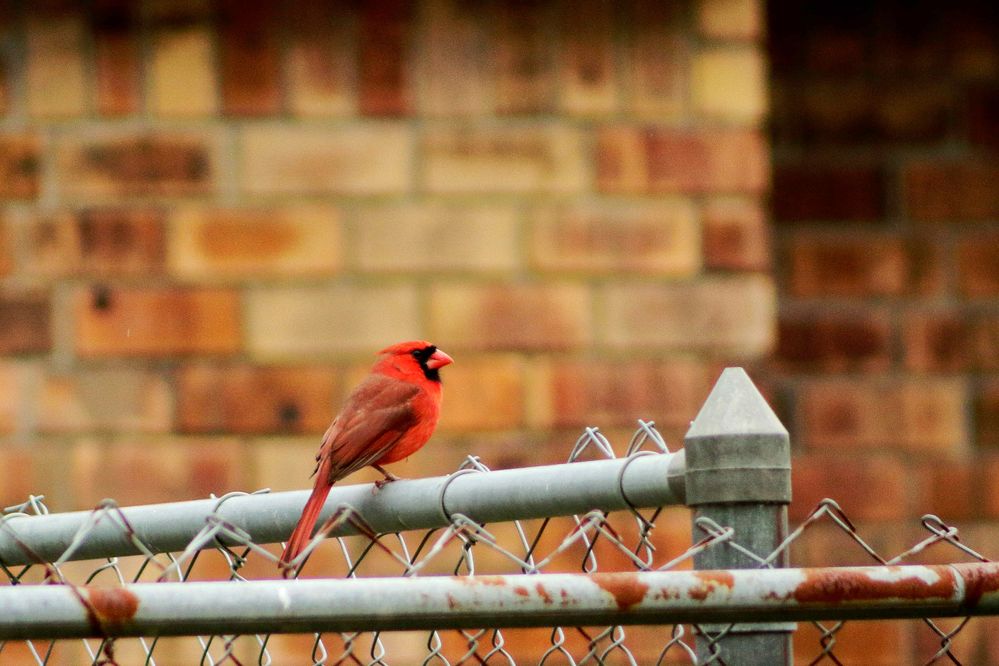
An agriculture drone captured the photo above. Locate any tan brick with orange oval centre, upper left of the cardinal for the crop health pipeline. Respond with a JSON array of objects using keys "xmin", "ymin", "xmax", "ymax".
[{"xmin": 169, "ymin": 206, "xmax": 343, "ymax": 280}]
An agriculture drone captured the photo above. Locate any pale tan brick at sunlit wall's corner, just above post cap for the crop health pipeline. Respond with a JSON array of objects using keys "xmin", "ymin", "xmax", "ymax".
[{"xmin": 601, "ymin": 275, "xmax": 776, "ymax": 357}]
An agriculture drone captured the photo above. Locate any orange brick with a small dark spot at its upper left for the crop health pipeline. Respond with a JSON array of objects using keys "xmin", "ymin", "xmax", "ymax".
[{"xmin": 74, "ymin": 286, "xmax": 241, "ymax": 356}]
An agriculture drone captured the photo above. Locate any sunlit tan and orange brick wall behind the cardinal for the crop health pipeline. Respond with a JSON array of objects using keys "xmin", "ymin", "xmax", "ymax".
[{"xmin": 0, "ymin": 0, "xmax": 776, "ymax": 510}]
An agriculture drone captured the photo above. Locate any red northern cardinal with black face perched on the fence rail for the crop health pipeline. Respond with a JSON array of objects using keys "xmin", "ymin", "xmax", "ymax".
[{"xmin": 279, "ymin": 340, "xmax": 454, "ymax": 577}]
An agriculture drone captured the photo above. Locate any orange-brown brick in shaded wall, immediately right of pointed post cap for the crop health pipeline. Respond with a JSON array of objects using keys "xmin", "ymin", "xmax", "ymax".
[{"xmin": 800, "ymin": 377, "xmax": 968, "ymax": 454}]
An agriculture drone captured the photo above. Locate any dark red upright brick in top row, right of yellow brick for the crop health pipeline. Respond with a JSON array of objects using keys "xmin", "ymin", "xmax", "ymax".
[{"xmin": 218, "ymin": 0, "xmax": 281, "ymax": 116}]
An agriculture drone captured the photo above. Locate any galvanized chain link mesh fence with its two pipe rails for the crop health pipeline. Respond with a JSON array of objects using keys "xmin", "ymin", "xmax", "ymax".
[{"xmin": 0, "ymin": 370, "xmax": 999, "ymax": 665}]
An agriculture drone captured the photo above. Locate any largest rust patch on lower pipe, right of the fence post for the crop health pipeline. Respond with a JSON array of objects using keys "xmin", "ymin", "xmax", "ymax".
[{"xmin": 790, "ymin": 566, "xmax": 956, "ymax": 604}]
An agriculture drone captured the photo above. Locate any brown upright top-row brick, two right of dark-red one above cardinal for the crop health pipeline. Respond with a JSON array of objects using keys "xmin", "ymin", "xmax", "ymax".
[{"xmin": 494, "ymin": 2, "xmax": 555, "ymax": 114}]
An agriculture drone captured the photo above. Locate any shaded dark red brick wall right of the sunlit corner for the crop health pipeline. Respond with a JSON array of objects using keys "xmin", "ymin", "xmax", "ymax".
[{"xmin": 768, "ymin": 0, "xmax": 999, "ymax": 608}]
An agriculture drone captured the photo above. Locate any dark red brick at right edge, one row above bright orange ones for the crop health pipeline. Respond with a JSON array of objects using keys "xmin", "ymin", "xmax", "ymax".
[{"xmin": 904, "ymin": 161, "xmax": 999, "ymax": 222}]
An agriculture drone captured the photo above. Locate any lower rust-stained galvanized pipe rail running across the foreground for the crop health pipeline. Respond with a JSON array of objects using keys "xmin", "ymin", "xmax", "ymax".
[{"xmin": 0, "ymin": 563, "xmax": 999, "ymax": 640}]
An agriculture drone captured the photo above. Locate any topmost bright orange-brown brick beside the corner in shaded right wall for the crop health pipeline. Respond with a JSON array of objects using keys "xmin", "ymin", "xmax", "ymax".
[{"xmin": 786, "ymin": 234, "xmax": 911, "ymax": 297}]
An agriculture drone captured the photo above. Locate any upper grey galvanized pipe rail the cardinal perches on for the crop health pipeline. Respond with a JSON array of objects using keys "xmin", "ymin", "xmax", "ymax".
[{"xmin": 0, "ymin": 451, "xmax": 685, "ymax": 564}]
